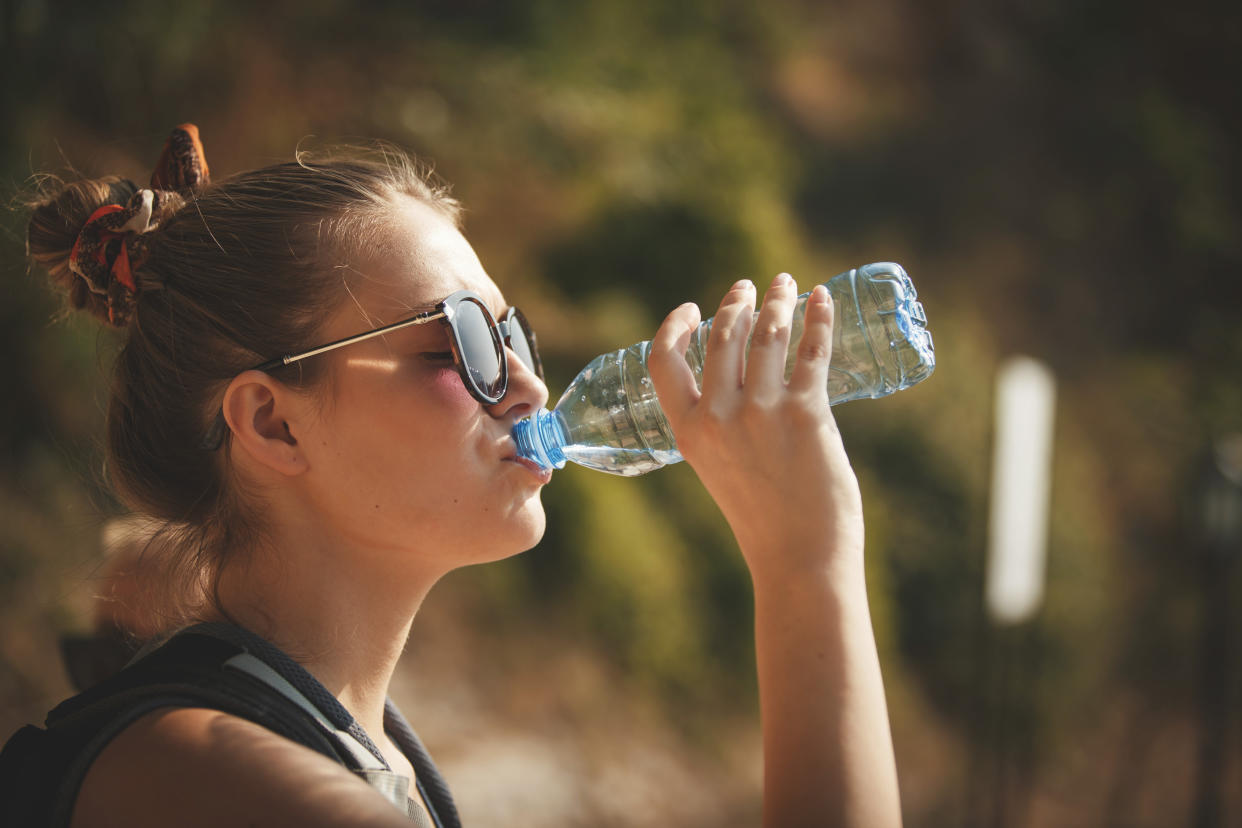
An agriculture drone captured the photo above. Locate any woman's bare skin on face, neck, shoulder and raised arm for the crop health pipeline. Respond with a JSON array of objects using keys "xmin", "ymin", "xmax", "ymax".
[{"xmin": 73, "ymin": 201, "xmax": 900, "ymax": 828}]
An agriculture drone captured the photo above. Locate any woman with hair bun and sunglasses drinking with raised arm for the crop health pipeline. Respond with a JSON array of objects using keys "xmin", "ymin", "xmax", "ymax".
[{"xmin": 7, "ymin": 124, "xmax": 900, "ymax": 828}]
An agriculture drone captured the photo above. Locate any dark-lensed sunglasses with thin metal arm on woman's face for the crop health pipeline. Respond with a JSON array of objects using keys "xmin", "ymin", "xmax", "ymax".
[{"xmin": 202, "ymin": 290, "xmax": 543, "ymax": 451}]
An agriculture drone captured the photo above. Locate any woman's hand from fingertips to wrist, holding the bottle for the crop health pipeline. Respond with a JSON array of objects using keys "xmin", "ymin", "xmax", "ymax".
[{"xmin": 648, "ymin": 273, "xmax": 863, "ymax": 580}]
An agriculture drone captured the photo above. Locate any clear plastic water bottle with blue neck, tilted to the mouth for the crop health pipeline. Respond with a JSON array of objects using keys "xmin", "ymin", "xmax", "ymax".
[{"xmin": 513, "ymin": 262, "xmax": 935, "ymax": 477}]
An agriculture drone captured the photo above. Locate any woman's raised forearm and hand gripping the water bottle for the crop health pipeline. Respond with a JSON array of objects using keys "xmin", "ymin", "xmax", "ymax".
[{"xmin": 647, "ymin": 274, "xmax": 902, "ymax": 828}]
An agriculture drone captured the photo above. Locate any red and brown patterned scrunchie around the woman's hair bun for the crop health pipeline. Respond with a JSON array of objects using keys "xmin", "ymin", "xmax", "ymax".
[{"xmin": 68, "ymin": 124, "xmax": 210, "ymax": 326}]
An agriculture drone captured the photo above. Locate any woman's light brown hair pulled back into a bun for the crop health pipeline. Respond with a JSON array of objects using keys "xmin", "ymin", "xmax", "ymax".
[{"xmin": 27, "ymin": 146, "xmax": 460, "ymax": 623}]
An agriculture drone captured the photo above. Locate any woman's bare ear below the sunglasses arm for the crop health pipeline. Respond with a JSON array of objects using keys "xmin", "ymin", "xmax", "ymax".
[{"xmin": 222, "ymin": 371, "xmax": 308, "ymax": 477}]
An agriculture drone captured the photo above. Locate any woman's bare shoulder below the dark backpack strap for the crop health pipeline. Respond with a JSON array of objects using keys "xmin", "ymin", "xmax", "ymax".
[{"xmin": 71, "ymin": 708, "xmax": 409, "ymax": 828}]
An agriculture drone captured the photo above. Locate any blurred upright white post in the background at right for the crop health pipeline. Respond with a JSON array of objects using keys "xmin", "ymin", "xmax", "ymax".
[{"xmin": 984, "ymin": 356, "xmax": 1056, "ymax": 624}]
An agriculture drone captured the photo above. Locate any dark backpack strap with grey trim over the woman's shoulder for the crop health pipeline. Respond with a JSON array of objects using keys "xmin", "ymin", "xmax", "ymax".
[{"xmin": 0, "ymin": 624, "xmax": 460, "ymax": 828}]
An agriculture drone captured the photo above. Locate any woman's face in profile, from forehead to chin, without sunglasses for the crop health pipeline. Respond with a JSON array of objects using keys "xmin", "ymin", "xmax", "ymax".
[{"xmin": 299, "ymin": 199, "xmax": 549, "ymax": 571}]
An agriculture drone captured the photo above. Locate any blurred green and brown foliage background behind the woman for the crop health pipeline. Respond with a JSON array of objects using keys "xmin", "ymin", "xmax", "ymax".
[{"xmin": 0, "ymin": 0, "xmax": 1242, "ymax": 827}]
